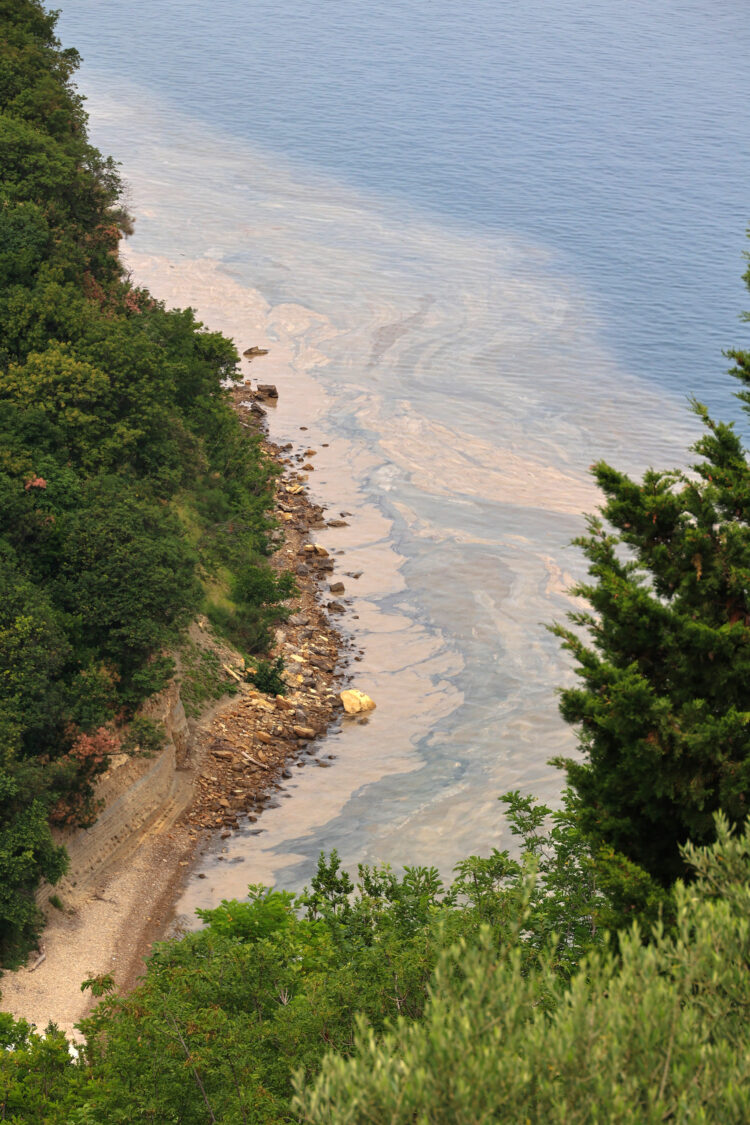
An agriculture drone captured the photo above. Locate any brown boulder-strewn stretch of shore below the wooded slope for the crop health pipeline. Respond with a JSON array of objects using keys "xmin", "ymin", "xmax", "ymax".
[{"xmin": 187, "ymin": 386, "xmax": 366, "ymax": 831}]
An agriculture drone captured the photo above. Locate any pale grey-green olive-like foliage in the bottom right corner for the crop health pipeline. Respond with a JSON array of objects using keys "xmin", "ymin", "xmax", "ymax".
[{"xmin": 299, "ymin": 820, "xmax": 750, "ymax": 1125}]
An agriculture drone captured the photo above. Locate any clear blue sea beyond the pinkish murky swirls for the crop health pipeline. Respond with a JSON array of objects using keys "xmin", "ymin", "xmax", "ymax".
[{"xmin": 61, "ymin": 0, "xmax": 750, "ymax": 410}]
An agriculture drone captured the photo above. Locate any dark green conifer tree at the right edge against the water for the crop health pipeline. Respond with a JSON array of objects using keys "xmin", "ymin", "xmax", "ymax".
[{"xmin": 553, "ymin": 257, "xmax": 750, "ymax": 883}]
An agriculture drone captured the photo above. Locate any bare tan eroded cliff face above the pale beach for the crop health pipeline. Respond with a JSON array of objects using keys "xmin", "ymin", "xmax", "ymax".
[{"xmin": 37, "ymin": 681, "xmax": 193, "ymax": 906}]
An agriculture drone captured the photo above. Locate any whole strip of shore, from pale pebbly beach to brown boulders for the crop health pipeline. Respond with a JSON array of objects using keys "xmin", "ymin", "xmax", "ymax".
[{"xmin": 0, "ymin": 380, "xmax": 352, "ymax": 1038}]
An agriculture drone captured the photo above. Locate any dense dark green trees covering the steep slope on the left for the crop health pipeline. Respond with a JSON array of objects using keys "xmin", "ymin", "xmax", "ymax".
[{"xmin": 0, "ymin": 0, "xmax": 284, "ymax": 961}]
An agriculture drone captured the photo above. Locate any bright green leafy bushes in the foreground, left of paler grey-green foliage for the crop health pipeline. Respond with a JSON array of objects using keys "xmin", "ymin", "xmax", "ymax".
[{"xmin": 0, "ymin": 793, "xmax": 652, "ymax": 1125}]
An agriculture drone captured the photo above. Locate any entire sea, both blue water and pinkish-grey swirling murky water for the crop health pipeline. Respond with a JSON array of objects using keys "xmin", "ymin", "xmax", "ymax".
[{"xmin": 61, "ymin": 0, "xmax": 750, "ymax": 908}]
